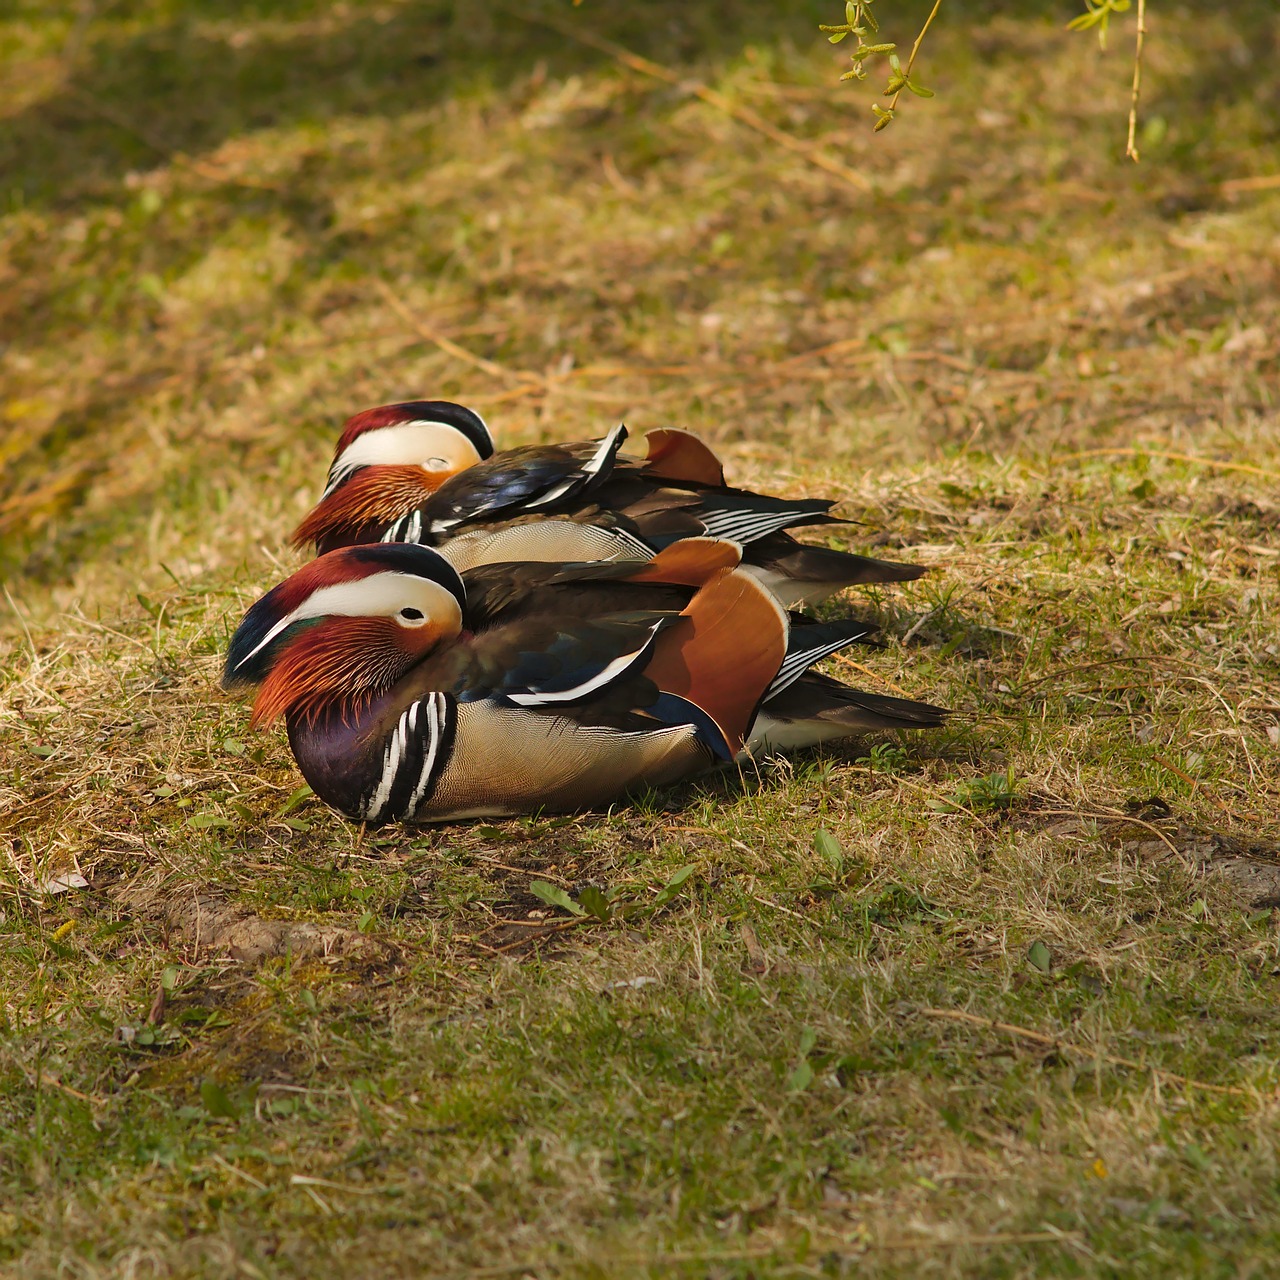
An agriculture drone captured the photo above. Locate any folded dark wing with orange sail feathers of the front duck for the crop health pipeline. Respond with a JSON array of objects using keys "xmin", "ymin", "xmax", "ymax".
[{"xmin": 450, "ymin": 539, "xmax": 788, "ymax": 759}]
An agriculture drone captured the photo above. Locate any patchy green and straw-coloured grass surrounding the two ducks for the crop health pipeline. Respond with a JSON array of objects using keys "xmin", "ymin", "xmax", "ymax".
[{"xmin": 0, "ymin": 0, "xmax": 1280, "ymax": 1277}]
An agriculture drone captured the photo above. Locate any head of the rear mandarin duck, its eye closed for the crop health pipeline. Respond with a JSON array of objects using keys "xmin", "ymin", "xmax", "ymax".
[{"xmin": 293, "ymin": 401, "xmax": 494, "ymax": 550}]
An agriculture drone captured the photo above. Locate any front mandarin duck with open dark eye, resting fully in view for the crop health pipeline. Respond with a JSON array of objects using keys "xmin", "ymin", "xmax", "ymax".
[{"xmin": 224, "ymin": 539, "xmax": 945, "ymax": 823}]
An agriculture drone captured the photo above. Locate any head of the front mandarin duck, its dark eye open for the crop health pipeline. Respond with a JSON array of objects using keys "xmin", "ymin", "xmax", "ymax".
[{"xmin": 223, "ymin": 543, "xmax": 466, "ymax": 726}]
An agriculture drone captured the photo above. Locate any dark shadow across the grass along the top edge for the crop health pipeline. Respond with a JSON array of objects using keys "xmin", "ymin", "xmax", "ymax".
[{"xmin": 12, "ymin": 0, "xmax": 1280, "ymax": 215}]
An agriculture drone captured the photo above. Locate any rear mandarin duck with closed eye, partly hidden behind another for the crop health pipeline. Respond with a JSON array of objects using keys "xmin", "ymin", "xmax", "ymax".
[{"xmin": 293, "ymin": 401, "xmax": 924, "ymax": 608}]
